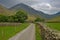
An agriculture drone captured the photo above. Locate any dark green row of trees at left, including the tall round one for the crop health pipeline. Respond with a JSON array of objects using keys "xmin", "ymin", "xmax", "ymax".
[{"xmin": 0, "ymin": 11, "xmax": 28, "ymax": 23}]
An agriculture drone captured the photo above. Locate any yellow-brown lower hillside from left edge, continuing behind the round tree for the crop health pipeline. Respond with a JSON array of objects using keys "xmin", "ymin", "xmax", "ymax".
[{"xmin": 0, "ymin": 5, "xmax": 35, "ymax": 21}]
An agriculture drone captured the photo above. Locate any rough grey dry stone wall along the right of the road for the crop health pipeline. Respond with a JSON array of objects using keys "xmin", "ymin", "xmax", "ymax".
[{"xmin": 38, "ymin": 23, "xmax": 60, "ymax": 40}]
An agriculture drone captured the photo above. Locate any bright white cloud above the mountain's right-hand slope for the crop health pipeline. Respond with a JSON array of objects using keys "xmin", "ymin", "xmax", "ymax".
[{"xmin": 31, "ymin": 3, "xmax": 60, "ymax": 15}]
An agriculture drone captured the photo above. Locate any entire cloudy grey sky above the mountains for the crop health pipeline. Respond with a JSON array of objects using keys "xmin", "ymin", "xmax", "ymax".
[{"xmin": 0, "ymin": 0, "xmax": 60, "ymax": 15}]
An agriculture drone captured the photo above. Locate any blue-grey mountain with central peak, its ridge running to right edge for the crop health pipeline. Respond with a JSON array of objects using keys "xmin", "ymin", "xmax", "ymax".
[{"xmin": 9, "ymin": 3, "xmax": 60, "ymax": 19}]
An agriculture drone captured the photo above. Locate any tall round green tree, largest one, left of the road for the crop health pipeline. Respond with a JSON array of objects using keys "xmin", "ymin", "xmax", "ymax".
[{"xmin": 15, "ymin": 11, "xmax": 28, "ymax": 23}]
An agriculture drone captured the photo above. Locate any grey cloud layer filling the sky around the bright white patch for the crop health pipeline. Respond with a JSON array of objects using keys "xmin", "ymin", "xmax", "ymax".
[{"xmin": 0, "ymin": 0, "xmax": 60, "ymax": 14}]
